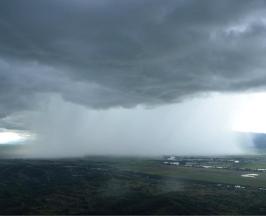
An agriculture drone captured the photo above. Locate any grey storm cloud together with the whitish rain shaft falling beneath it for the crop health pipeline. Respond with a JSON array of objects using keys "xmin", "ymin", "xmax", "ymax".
[{"xmin": 0, "ymin": 0, "xmax": 266, "ymax": 155}]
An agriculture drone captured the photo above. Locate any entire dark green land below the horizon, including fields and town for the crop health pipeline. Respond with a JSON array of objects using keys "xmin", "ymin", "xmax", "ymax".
[{"xmin": 0, "ymin": 157, "xmax": 266, "ymax": 214}]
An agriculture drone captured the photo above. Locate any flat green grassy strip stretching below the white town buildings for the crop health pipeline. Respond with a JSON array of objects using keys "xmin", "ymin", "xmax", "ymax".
[{"xmin": 92, "ymin": 158, "xmax": 266, "ymax": 188}]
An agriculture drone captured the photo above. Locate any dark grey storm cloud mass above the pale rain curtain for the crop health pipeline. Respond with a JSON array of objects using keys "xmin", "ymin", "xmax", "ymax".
[{"xmin": 0, "ymin": 0, "xmax": 266, "ymax": 116}]
